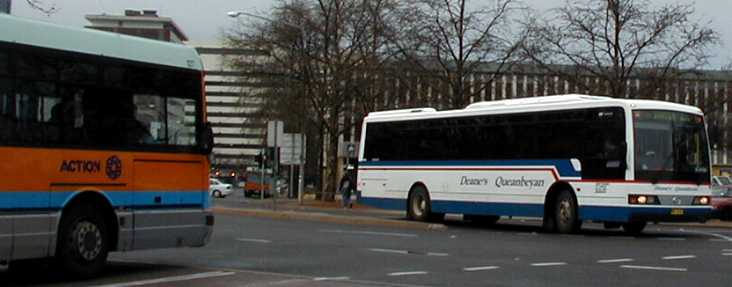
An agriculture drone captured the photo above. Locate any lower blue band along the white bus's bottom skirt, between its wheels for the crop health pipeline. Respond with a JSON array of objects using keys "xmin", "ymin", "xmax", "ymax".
[{"xmin": 359, "ymin": 197, "xmax": 711, "ymax": 222}]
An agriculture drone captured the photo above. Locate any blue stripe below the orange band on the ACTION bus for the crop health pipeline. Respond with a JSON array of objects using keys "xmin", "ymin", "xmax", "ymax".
[{"xmin": 0, "ymin": 191, "xmax": 210, "ymax": 210}]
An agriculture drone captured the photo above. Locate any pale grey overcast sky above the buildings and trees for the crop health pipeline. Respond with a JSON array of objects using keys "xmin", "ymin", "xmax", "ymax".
[{"xmin": 12, "ymin": 0, "xmax": 732, "ymax": 69}]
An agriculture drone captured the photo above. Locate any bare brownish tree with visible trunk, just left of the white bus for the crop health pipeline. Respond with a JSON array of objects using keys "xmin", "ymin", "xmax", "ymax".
[{"xmin": 227, "ymin": 0, "xmax": 395, "ymax": 201}]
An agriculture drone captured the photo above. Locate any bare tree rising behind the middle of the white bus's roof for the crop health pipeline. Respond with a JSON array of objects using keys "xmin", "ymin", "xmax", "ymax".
[{"xmin": 392, "ymin": 0, "xmax": 526, "ymax": 108}]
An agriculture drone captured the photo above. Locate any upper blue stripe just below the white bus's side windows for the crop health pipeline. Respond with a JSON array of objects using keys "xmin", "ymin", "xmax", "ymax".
[{"xmin": 359, "ymin": 159, "xmax": 581, "ymax": 177}]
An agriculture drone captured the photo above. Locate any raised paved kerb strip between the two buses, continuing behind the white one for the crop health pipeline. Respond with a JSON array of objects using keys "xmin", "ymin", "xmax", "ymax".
[{"xmin": 207, "ymin": 195, "xmax": 732, "ymax": 229}]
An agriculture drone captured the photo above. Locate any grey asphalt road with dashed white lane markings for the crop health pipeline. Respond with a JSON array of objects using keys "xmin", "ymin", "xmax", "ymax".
[{"xmin": 0, "ymin": 199, "xmax": 732, "ymax": 287}]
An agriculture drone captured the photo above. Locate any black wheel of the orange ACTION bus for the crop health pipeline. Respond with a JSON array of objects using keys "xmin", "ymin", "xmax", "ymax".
[{"xmin": 56, "ymin": 204, "xmax": 109, "ymax": 278}]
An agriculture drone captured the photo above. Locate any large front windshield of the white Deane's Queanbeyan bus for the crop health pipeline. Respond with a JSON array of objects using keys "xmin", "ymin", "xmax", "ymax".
[{"xmin": 633, "ymin": 110, "xmax": 709, "ymax": 184}]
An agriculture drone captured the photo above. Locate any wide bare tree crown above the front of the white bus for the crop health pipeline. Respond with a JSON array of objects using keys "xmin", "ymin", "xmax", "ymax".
[{"xmin": 523, "ymin": 0, "xmax": 718, "ymax": 97}]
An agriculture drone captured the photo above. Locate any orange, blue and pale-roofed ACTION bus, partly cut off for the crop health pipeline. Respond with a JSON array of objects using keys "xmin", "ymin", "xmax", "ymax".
[{"xmin": 0, "ymin": 15, "xmax": 214, "ymax": 276}]
